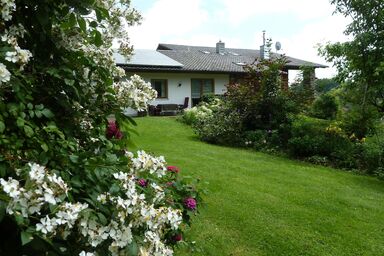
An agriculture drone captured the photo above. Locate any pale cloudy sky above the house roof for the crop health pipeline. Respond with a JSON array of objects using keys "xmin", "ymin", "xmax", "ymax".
[{"xmin": 129, "ymin": 0, "xmax": 348, "ymax": 78}]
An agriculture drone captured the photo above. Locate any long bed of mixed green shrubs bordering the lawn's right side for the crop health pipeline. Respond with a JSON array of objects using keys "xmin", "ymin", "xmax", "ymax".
[{"xmin": 182, "ymin": 52, "xmax": 384, "ymax": 176}]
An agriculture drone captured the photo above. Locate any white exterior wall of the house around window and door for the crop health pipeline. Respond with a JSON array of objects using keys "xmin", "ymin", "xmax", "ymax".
[{"xmin": 127, "ymin": 72, "xmax": 229, "ymax": 107}]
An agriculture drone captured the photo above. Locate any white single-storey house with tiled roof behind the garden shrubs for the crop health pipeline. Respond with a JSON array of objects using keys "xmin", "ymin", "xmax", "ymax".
[{"xmin": 115, "ymin": 42, "xmax": 326, "ymax": 113}]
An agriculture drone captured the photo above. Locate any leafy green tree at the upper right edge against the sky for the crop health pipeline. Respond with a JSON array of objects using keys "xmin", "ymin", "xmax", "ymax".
[{"xmin": 320, "ymin": 0, "xmax": 384, "ymax": 115}]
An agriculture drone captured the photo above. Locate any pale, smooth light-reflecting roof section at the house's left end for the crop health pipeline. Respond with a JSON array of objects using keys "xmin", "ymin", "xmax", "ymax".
[{"xmin": 113, "ymin": 49, "xmax": 183, "ymax": 68}]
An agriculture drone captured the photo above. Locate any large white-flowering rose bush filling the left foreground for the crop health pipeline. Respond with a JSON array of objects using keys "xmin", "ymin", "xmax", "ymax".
[{"xmin": 0, "ymin": 0, "xmax": 201, "ymax": 256}]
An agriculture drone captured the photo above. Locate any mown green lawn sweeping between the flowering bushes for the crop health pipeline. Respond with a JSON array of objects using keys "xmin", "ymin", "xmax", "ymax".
[{"xmin": 134, "ymin": 117, "xmax": 384, "ymax": 256}]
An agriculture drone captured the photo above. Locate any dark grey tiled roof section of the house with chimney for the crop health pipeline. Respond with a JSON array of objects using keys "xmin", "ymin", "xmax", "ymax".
[{"xmin": 118, "ymin": 44, "xmax": 327, "ymax": 73}]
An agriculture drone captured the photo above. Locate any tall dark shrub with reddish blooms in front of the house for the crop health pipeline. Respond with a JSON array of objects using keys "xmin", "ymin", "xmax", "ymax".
[{"xmin": 227, "ymin": 57, "xmax": 292, "ymax": 130}]
